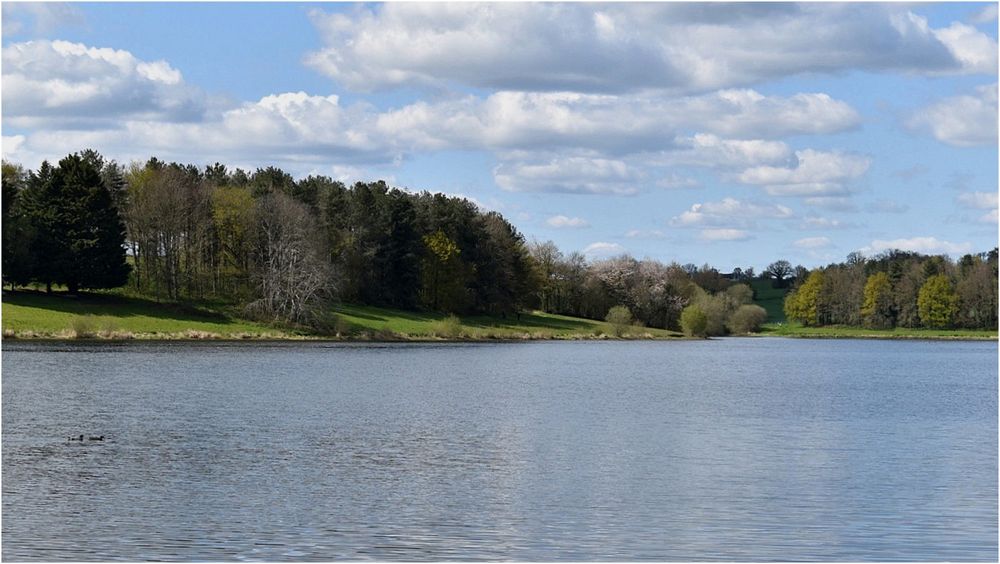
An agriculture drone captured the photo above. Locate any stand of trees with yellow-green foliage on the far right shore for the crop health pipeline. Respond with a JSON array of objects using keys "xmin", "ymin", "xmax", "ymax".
[{"xmin": 785, "ymin": 248, "xmax": 997, "ymax": 330}]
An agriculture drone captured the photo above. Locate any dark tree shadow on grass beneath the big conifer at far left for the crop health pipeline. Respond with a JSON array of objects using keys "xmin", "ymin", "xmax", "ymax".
[{"xmin": 3, "ymin": 290, "xmax": 233, "ymax": 324}]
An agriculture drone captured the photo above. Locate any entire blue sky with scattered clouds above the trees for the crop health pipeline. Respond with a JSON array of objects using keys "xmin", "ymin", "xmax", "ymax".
[{"xmin": 0, "ymin": 2, "xmax": 998, "ymax": 271}]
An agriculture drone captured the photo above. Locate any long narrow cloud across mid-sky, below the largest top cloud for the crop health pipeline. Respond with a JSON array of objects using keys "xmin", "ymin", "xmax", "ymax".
[{"xmin": 377, "ymin": 90, "xmax": 860, "ymax": 153}]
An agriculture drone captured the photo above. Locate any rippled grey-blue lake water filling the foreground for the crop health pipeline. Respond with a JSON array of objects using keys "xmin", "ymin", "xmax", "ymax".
[{"xmin": 2, "ymin": 339, "xmax": 998, "ymax": 561}]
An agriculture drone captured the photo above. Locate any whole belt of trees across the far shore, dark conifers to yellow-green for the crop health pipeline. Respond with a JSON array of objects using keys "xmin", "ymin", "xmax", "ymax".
[{"xmin": 2, "ymin": 150, "xmax": 997, "ymax": 335}]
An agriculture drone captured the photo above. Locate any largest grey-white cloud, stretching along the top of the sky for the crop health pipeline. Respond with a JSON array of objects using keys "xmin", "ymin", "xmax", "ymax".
[{"xmin": 305, "ymin": 3, "xmax": 997, "ymax": 92}]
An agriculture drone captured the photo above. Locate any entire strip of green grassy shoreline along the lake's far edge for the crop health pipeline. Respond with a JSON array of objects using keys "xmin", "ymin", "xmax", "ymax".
[{"xmin": 3, "ymin": 293, "xmax": 998, "ymax": 343}]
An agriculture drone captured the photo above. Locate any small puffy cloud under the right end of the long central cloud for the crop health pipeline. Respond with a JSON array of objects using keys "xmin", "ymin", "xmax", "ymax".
[{"xmin": 739, "ymin": 149, "xmax": 871, "ymax": 197}]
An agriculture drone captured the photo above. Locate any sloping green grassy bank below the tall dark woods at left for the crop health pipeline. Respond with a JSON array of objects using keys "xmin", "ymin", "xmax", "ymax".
[{"xmin": 3, "ymin": 292, "xmax": 680, "ymax": 341}]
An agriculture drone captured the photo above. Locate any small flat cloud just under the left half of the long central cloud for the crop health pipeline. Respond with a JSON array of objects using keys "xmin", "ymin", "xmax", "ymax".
[{"xmin": 493, "ymin": 157, "xmax": 641, "ymax": 195}]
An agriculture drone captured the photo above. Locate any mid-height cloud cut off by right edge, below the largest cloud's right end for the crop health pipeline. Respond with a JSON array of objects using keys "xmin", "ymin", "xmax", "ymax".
[{"xmin": 907, "ymin": 84, "xmax": 997, "ymax": 147}]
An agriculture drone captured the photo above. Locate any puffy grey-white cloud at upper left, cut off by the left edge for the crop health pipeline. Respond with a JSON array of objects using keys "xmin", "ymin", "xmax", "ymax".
[{"xmin": 2, "ymin": 40, "xmax": 207, "ymax": 127}]
